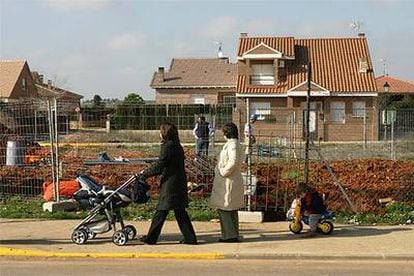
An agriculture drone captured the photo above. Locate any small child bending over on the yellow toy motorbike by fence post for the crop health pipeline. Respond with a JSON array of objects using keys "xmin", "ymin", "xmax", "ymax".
[{"xmin": 296, "ymin": 182, "xmax": 326, "ymax": 238}]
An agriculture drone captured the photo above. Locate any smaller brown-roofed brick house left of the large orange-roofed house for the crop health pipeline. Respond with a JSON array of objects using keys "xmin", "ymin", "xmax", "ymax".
[{"xmin": 150, "ymin": 57, "xmax": 237, "ymax": 104}]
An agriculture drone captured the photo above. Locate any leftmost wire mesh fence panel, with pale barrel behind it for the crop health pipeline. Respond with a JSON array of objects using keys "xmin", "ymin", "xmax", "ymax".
[{"xmin": 0, "ymin": 101, "xmax": 52, "ymax": 196}]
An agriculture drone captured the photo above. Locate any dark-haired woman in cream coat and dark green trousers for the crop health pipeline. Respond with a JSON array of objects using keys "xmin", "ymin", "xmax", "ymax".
[{"xmin": 210, "ymin": 123, "xmax": 244, "ymax": 242}]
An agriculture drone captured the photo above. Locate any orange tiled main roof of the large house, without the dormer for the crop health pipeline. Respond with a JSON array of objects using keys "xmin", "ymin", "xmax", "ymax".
[{"xmin": 237, "ymin": 38, "xmax": 377, "ymax": 93}]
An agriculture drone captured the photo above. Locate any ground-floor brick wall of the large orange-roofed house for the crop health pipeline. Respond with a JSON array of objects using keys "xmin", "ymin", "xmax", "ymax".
[{"xmin": 233, "ymin": 97, "xmax": 378, "ymax": 141}]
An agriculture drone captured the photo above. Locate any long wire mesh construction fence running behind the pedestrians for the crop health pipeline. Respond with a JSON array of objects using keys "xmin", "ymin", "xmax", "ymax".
[{"xmin": 0, "ymin": 101, "xmax": 414, "ymax": 216}]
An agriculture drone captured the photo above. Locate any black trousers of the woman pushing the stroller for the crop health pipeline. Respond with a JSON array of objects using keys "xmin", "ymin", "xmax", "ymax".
[{"xmin": 146, "ymin": 209, "xmax": 197, "ymax": 243}]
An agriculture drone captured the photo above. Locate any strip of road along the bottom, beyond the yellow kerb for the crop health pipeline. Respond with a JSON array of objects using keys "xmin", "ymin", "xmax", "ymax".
[{"xmin": 0, "ymin": 258, "xmax": 414, "ymax": 276}]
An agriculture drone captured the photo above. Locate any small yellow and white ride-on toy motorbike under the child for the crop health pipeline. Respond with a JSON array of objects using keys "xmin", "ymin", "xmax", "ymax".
[{"xmin": 286, "ymin": 199, "xmax": 334, "ymax": 235}]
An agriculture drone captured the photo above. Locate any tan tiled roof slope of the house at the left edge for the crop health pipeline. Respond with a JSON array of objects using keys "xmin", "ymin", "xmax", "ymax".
[{"xmin": 0, "ymin": 60, "xmax": 26, "ymax": 98}]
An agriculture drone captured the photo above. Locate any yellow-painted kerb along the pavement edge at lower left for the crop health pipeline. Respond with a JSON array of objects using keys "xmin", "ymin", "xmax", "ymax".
[{"xmin": 0, "ymin": 247, "xmax": 225, "ymax": 259}]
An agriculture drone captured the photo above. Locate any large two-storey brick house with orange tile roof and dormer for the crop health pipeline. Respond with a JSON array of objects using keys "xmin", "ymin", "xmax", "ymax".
[{"xmin": 234, "ymin": 33, "xmax": 378, "ymax": 141}]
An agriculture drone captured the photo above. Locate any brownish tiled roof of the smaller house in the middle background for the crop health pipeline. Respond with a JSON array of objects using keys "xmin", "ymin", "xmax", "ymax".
[{"xmin": 151, "ymin": 58, "xmax": 237, "ymax": 88}]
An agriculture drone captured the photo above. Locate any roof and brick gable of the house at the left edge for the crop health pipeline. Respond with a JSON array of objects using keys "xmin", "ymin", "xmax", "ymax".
[{"xmin": 0, "ymin": 60, "xmax": 39, "ymax": 102}]
